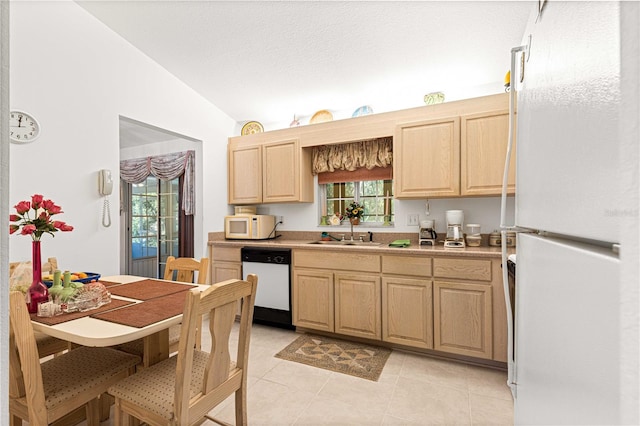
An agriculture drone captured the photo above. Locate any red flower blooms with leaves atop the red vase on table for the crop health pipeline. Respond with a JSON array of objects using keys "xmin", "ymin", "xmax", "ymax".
[{"xmin": 9, "ymin": 194, "xmax": 73, "ymax": 241}]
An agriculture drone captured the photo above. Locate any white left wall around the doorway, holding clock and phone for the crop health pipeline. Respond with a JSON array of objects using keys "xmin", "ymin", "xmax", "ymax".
[{"xmin": 9, "ymin": 1, "xmax": 235, "ymax": 275}]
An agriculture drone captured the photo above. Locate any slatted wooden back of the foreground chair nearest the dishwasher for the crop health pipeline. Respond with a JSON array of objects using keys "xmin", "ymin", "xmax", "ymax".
[{"xmin": 174, "ymin": 274, "xmax": 258, "ymax": 424}]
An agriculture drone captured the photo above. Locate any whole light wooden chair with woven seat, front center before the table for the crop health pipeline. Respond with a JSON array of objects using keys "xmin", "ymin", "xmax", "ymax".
[{"xmin": 109, "ymin": 275, "xmax": 258, "ymax": 426}]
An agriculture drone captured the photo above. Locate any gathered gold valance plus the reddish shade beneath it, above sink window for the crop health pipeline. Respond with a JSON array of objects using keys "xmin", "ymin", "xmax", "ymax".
[{"xmin": 312, "ymin": 137, "xmax": 393, "ymax": 183}]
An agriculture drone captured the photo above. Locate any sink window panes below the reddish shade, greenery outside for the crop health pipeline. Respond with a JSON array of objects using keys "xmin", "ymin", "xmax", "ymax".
[{"xmin": 320, "ymin": 179, "xmax": 394, "ymax": 225}]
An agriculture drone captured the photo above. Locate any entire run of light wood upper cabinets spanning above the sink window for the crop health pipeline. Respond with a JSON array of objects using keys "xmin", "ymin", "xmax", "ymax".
[{"xmin": 228, "ymin": 93, "xmax": 515, "ymax": 205}]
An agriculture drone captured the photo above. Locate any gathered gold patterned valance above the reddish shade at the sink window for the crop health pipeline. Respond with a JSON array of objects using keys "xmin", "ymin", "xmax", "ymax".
[{"xmin": 312, "ymin": 137, "xmax": 393, "ymax": 175}]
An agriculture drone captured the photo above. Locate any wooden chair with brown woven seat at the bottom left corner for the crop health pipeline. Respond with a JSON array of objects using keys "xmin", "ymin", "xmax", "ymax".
[{"xmin": 9, "ymin": 291, "xmax": 140, "ymax": 426}]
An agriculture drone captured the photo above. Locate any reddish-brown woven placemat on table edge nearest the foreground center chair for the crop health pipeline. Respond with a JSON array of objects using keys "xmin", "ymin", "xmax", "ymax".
[{"xmin": 91, "ymin": 290, "xmax": 189, "ymax": 328}]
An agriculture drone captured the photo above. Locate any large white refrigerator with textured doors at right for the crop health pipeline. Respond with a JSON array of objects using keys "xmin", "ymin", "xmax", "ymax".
[{"xmin": 501, "ymin": 0, "xmax": 628, "ymax": 425}]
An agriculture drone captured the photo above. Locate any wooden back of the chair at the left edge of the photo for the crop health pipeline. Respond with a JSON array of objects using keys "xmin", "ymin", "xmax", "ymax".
[{"xmin": 9, "ymin": 291, "xmax": 47, "ymax": 425}]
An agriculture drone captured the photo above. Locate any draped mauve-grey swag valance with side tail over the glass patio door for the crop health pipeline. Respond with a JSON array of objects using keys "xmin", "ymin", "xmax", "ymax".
[{"xmin": 120, "ymin": 151, "xmax": 196, "ymax": 215}]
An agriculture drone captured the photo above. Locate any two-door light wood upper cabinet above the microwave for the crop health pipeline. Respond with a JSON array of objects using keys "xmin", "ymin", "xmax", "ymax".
[{"xmin": 228, "ymin": 139, "xmax": 314, "ymax": 204}]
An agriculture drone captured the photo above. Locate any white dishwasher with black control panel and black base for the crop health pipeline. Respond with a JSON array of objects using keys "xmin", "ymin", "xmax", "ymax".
[{"xmin": 241, "ymin": 247, "xmax": 295, "ymax": 329}]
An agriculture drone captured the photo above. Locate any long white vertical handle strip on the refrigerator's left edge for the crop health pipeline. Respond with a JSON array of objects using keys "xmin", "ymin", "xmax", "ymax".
[{"xmin": 500, "ymin": 45, "xmax": 527, "ymax": 398}]
